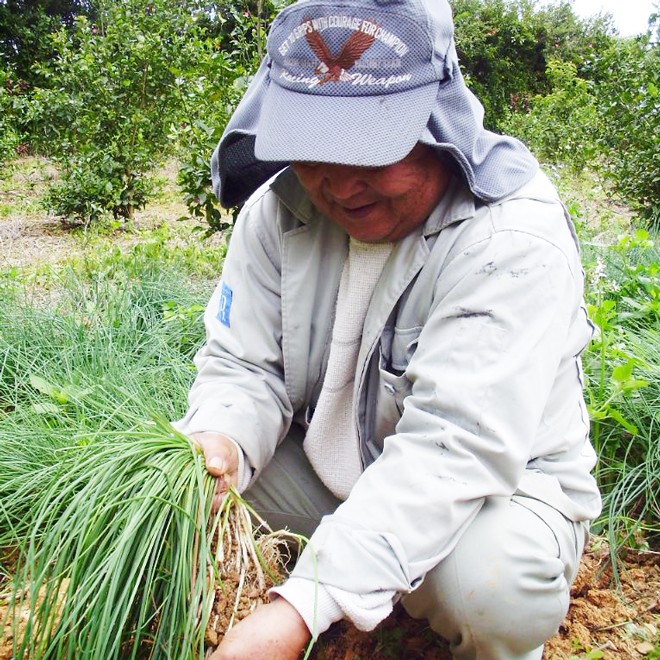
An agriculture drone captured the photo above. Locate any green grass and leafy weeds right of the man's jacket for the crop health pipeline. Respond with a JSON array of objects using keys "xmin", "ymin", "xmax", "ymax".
[{"xmin": 584, "ymin": 230, "xmax": 660, "ymax": 556}]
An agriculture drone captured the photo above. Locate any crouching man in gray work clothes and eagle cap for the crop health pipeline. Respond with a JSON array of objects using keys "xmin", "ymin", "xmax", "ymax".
[{"xmin": 180, "ymin": 0, "xmax": 600, "ymax": 659}]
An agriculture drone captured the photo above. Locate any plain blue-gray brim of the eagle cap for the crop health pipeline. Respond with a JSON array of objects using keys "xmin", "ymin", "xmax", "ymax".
[{"xmin": 255, "ymin": 82, "xmax": 439, "ymax": 167}]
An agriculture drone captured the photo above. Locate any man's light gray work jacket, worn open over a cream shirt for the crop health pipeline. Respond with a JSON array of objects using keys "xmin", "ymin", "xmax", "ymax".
[{"xmin": 180, "ymin": 165, "xmax": 600, "ymax": 628}]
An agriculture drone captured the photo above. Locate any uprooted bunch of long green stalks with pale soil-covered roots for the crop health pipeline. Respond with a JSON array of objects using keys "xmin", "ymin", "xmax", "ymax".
[{"xmin": 5, "ymin": 421, "xmax": 292, "ymax": 660}]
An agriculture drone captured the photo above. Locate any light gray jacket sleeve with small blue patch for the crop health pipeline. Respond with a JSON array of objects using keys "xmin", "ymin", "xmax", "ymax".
[{"xmin": 177, "ymin": 188, "xmax": 292, "ymax": 478}]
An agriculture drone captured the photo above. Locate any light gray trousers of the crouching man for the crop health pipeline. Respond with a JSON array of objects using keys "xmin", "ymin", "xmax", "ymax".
[{"xmin": 245, "ymin": 433, "xmax": 588, "ymax": 660}]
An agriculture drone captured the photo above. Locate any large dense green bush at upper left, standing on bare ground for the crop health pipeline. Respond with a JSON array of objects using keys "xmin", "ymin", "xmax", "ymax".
[{"xmin": 32, "ymin": 0, "xmax": 204, "ymax": 221}]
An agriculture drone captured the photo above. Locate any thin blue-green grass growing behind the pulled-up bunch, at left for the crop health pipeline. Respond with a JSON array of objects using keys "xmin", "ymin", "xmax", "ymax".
[{"xmin": 0, "ymin": 266, "xmax": 208, "ymax": 560}]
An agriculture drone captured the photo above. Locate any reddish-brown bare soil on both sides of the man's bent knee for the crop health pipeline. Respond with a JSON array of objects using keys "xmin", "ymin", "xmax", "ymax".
[{"xmin": 311, "ymin": 539, "xmax": 660, "ymax": 660}]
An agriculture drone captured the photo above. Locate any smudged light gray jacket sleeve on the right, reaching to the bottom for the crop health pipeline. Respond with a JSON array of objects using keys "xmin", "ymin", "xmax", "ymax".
[{"xmin": 278, "ymin": 201, "xmax": 584, "ymax": 632}]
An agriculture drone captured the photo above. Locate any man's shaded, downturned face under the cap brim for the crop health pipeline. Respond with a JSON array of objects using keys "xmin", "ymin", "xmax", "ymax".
[{"xmin": 292, "ymin": 144, "xmax": 450, "ymax": 243}]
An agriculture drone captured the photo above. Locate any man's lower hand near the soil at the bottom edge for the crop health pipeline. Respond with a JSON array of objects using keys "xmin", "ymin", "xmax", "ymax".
[{"xmin": 209, "ymin": 598, "xmax": 311, "ymax": 660}]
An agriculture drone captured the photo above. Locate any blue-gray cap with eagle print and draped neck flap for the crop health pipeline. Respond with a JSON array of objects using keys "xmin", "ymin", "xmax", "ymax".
[{"xmin": 211, "ymin": 0, "xmax": 538, "ymax": 207}]
